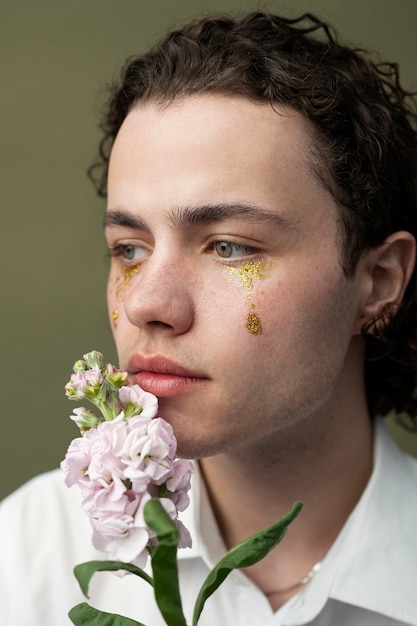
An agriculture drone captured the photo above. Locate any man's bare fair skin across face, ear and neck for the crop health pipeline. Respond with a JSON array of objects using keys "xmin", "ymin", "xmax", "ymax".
[{"xmin": 106, "ymin": 94, "xmax": 412, "ymax": 608}]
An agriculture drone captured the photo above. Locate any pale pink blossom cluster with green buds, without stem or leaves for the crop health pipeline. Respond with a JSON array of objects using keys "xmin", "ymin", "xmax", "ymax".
[{"xmin": 61, "ymin": 352, "xmax": 193, "ymax": 567}]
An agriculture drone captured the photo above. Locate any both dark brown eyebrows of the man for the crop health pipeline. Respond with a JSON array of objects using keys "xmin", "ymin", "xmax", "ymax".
[{"xmin": 104, "ymin": 202, "xmax": 296, "ymax": 231}]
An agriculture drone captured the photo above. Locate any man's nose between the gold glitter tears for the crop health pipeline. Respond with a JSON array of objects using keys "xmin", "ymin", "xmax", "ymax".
[{"xmin": 124, "ymin": 255, "xmax": 194, "ymax": 335}]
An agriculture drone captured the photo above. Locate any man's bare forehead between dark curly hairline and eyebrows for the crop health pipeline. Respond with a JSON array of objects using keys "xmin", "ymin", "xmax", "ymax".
[{"xmin": 108, "ymin": 94, "xmax": 329, "ymax": 224}]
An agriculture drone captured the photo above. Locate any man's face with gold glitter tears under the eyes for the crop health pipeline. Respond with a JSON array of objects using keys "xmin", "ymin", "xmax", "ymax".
[{"xmin": 106, "ymin": 95, "xmax": 360, "ymax": 457}]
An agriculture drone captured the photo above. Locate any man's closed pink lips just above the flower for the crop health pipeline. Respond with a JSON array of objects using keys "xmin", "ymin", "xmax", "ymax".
[{"xmin": 127, "ymin": 354, "xmax": 208, "ymax": 398}]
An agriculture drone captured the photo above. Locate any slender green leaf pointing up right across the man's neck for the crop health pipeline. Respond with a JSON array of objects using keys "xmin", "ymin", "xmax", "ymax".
[{"xmin": 192, "ymin": 502, "xmax": 303, "ymax": 626}]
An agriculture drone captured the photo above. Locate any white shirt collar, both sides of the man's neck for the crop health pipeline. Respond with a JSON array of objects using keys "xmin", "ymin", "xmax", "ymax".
[{"xmin": 178, "ymin": 419, "xmax": 417, "ymax": 626}]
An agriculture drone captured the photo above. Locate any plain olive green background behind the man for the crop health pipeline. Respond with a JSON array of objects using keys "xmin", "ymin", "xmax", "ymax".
[{"xmin": 0, "ymin": 0, "xmax": 417, "ymax": 498}]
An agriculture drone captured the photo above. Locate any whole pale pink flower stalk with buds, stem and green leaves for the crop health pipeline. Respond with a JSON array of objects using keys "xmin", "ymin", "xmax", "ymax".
[{"xmin": 61, "ymin": 351, "xmax": 302, "ymax": 626}]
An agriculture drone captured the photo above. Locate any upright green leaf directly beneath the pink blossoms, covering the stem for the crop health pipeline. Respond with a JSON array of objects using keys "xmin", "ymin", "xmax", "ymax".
[{"xmin": 144, "ymin": 498, "xmax": 187, "ymax": 626}]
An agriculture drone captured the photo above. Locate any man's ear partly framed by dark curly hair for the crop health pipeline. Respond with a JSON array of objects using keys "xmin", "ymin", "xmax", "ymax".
[{"xmin": 356, "ymin": 231, "xmax": 416, "ymax": 332}]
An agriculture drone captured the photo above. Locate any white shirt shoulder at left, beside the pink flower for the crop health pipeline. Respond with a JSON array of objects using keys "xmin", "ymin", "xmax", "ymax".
[{"xmin": 0, "ymin": 470, "xmax": 99, "ymax": 626}]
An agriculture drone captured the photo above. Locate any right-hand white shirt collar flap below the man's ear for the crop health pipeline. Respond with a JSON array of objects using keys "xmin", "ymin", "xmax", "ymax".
[{"xmin": 330, "ymin": 420, "xmax": 417, "ymax": 626}]
